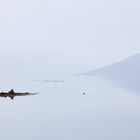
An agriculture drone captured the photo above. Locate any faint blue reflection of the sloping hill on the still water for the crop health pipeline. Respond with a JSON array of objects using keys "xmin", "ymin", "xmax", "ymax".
[{"xmin": 105, "ymin": 75, "xmax": 140, "ymax": 92}]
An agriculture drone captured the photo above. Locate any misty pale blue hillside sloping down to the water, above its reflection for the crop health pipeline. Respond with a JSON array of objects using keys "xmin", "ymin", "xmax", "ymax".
[{"xmin": 84, "ymin": 54, "xmax": 140, "ymax": 75}]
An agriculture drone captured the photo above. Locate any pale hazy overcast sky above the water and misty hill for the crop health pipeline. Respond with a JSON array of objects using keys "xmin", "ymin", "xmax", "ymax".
[{"xmin": 0, "ymin": 0, "xmax": 140, "ymax": 76}]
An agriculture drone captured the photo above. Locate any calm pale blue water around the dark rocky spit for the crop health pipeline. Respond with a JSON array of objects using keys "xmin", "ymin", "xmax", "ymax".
[{"xmin": 0, "ymin": 76, "xmax": 140, "ymax": 140}]
